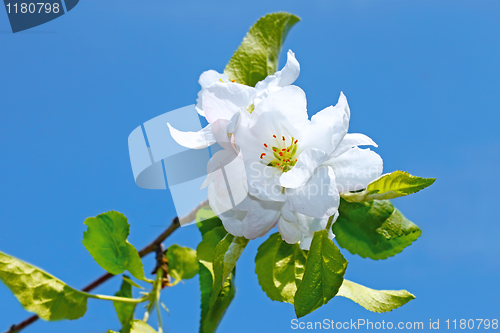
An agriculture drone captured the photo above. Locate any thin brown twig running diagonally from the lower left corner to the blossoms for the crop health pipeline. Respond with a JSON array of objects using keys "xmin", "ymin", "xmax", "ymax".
[{"xmin": 5, "ymin": 201, "xmax": 208, "ymax": 333}]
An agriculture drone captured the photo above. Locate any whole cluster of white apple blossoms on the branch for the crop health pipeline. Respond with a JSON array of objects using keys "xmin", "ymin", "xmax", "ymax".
[{"xmin": 169, "ymin": 51, "xmax": 382, "ymax": 249}]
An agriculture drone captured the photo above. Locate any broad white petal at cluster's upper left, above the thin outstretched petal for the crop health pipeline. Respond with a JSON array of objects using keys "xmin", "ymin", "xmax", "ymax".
[{"xmin": 202, "ymin": 82, "xmax": 255, "ymax": 123}]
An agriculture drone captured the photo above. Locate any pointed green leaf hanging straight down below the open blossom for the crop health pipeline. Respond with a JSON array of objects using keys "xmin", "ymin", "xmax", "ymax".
[{"xmin": 294, "ymin": 230, "xmax": 347, "ymax": 318}]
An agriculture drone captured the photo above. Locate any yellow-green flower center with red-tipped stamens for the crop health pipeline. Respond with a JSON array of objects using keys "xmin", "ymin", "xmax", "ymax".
[{"xmin": 260, "ymin": 135, "xmax": 299, "ymax": 172}]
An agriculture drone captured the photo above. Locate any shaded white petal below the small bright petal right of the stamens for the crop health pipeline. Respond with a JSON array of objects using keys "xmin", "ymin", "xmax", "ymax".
[{"xmin": 285, "ymin": 166, "xmax": 340, "ymax": 218}]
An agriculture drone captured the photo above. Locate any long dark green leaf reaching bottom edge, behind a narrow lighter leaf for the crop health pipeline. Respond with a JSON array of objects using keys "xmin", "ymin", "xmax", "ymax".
[{"xmin": 196, "ymin": 227, "xmax": 236, "ymax": 333}]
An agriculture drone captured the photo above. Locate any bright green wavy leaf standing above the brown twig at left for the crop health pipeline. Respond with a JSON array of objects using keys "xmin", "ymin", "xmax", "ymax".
[{"xmin": 83, "ymin": 211, "xmax": 144, "ymax": 280}]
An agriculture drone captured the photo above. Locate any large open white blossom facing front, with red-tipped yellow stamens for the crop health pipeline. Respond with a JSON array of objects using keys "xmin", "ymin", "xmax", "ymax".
[{"xmin": 221, "ymin": 86, "xmax": 382, "ymax": 243}]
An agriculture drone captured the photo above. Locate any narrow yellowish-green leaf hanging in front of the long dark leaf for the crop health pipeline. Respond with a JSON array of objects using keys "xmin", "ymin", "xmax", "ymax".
[{"xmin": 209, "ymin": 234, "xmax": 248, "ymax": 306}]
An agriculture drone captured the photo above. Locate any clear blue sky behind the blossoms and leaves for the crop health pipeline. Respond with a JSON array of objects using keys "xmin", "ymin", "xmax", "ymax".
[{"xmin": 0, "ymin": 0, "xmax": 500, "ymax": 333}]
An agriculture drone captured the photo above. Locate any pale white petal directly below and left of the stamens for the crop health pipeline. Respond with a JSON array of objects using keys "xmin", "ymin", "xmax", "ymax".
[{"xmin": 245, "ymin": 161, "xmax": 285, "ymax": 202}]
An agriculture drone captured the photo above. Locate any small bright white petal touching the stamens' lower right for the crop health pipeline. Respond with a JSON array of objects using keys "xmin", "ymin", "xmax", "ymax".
[{"xmin": 280, "ymin": 148, "xmax": 328, "ymax": 188}]
